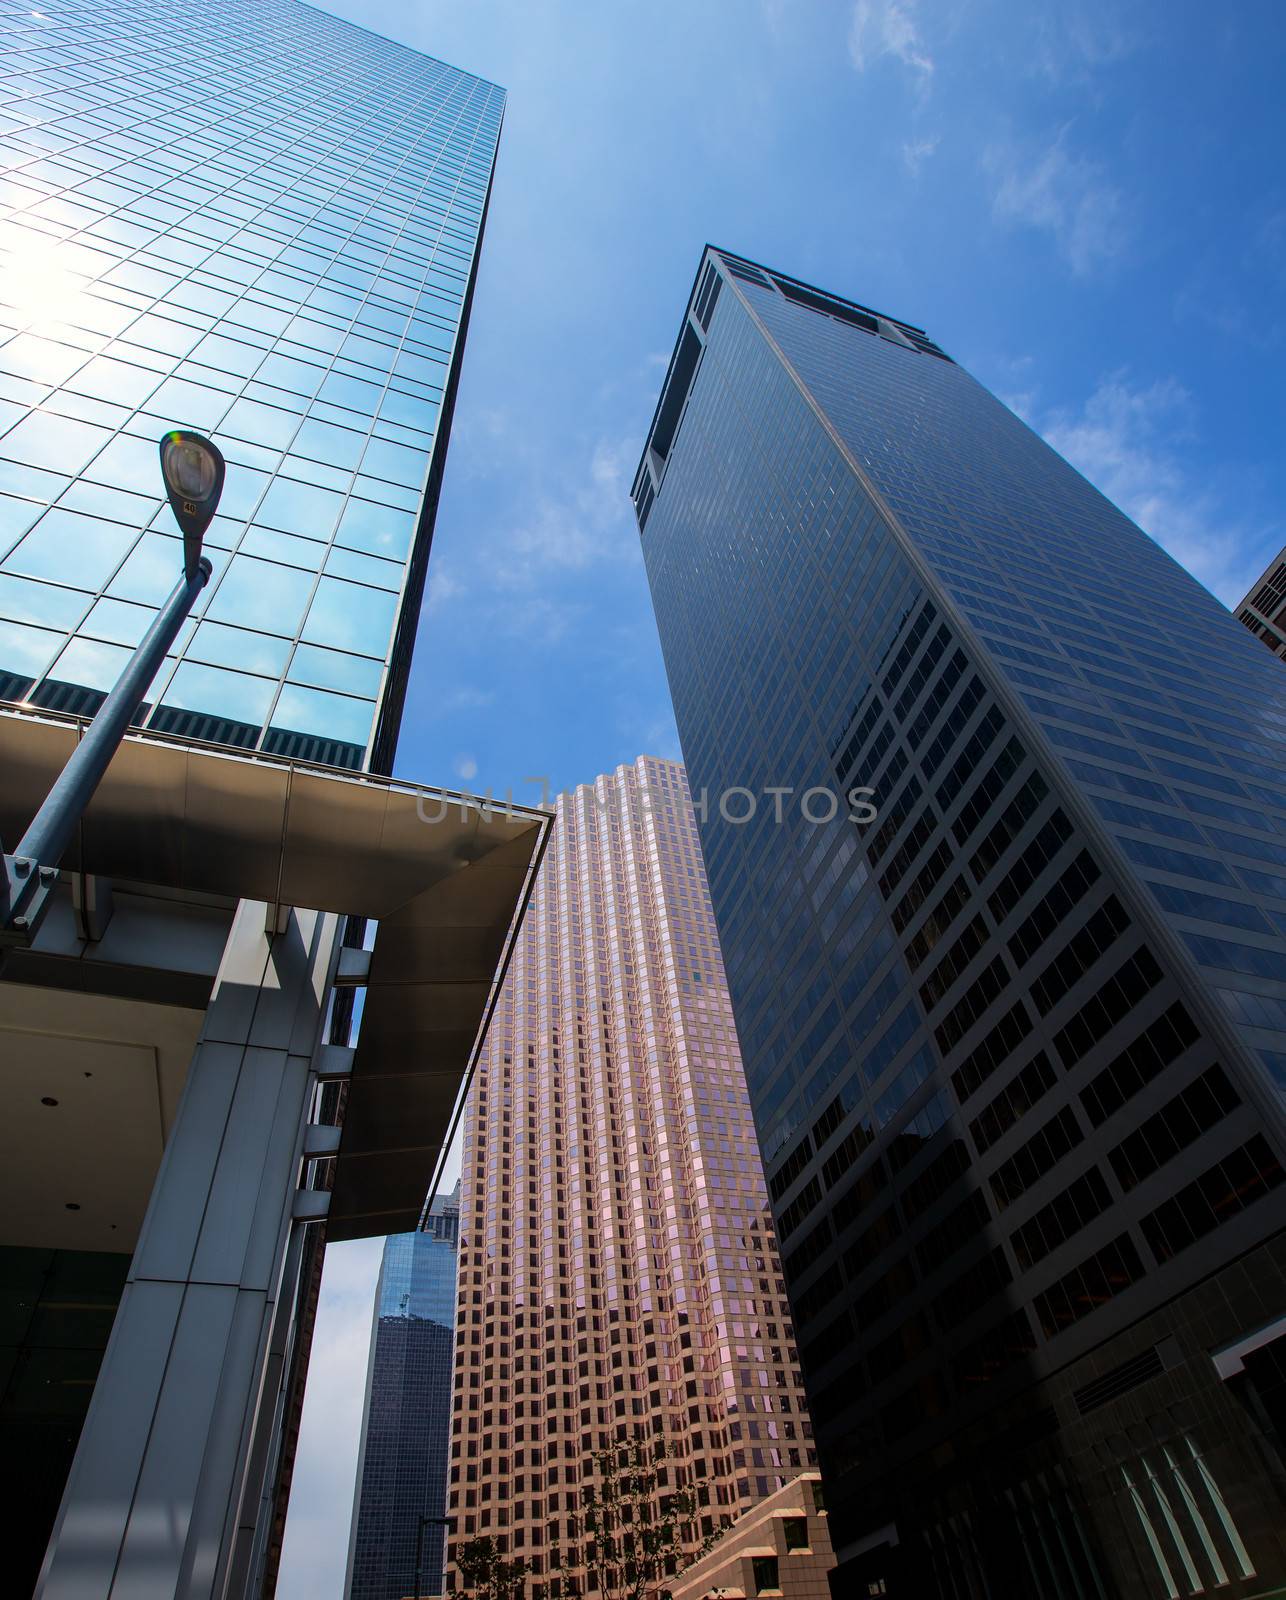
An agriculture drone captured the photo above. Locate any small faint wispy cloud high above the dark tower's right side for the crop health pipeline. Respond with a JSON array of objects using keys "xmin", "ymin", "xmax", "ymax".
[{"xmin": 984, "ymin": 128, "xmax": 1131, "ymax": 277}]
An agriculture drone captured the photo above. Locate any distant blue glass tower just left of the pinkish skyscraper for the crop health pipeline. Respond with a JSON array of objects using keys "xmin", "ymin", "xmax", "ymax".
[{"xmin": 347, "ymin": 1184, "xmax": 461, "ymax": 1600}]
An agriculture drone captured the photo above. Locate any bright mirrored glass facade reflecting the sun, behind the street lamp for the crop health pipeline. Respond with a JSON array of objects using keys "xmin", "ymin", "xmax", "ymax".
[{"xmin": 0, "ymin": 0, "xmax": 504, "ymax": 770}]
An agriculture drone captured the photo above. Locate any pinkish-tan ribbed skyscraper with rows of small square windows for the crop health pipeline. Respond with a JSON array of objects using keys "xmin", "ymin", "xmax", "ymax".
[{"xmin": 449, "ymin": 757, "xmax": 813, "ymax": 1595}]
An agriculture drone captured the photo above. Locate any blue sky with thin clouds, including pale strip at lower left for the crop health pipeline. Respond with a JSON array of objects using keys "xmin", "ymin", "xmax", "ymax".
[{"xmin": 280, "ymin": 0, "xmax": 1286, "ymax": 1600}]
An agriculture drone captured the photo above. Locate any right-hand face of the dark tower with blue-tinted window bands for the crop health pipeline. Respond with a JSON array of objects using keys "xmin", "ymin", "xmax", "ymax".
[{"xmin": 744, "ymin": 268, "xmax": 1286, "ymax": 1082}]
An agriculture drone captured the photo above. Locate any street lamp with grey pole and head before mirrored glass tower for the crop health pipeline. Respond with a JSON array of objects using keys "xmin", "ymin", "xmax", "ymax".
[{"xmin": 0, "ymin": 429, "xmax": 226, "ymax": 947}]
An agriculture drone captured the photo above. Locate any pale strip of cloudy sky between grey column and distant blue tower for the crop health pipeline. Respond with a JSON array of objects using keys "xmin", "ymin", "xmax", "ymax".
[{"xmin": 277, "ymin": 1238, "xmax": 384, "ymax": 1600}]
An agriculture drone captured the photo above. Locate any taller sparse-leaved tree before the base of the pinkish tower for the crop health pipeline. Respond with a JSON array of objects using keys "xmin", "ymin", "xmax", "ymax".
[{"xmin": 581, "ymin": 1440, "xmax": 697, "ymax": 1600}]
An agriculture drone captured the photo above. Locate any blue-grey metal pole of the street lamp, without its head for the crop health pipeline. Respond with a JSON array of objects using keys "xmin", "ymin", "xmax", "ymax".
[{"xmin": 13, "ymin": 557, "xmax": 211, "ymax": 867}]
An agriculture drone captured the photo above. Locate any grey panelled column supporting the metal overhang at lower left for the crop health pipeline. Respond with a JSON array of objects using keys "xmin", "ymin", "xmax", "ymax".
[{"xmin": 35, "ymin": 901, "xmax": 339, "ymax": 1600}]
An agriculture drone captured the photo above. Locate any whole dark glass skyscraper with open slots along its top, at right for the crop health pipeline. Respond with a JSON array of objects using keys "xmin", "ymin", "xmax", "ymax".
[{"xmin": 635, "ymin": 250, "xmax": 1286, "ymax": 1600}]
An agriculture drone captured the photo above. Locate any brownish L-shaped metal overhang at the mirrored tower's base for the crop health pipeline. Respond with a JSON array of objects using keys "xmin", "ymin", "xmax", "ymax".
[{"xmin": 0, "ymin": 704, "xmax": 550, "ymax": 1238}]
